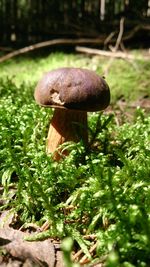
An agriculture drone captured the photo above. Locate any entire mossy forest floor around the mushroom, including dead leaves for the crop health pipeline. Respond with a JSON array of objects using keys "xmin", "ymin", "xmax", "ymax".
[{"xmin": 0, "ymin": 51, "xmax": 150, "ymax": 267}]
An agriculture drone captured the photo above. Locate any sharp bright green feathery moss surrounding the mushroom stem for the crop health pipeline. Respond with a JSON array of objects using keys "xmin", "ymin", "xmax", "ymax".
[{"xmin": 0, "ymin": 76, "xmax": 150, "ymax": 267}]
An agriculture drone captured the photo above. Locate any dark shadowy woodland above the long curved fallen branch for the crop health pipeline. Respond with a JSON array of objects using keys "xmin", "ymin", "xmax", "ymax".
[{"xmin": 0, "ymin": 0, "xmax": 150, "ymax": 51}]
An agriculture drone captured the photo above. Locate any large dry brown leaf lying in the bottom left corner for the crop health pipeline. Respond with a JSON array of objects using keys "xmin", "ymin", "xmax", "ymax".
[{"xmin": 0, "ymin": 227, "xmax": 63, "ymax": 267}]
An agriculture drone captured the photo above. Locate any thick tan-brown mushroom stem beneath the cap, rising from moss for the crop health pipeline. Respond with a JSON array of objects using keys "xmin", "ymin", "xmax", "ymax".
[{"xmin": 47, "ymin": 108, "xmax": 88, "ymax": 160}]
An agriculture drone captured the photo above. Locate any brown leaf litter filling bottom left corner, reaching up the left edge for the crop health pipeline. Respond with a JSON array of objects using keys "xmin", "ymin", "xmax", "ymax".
[{"xmin": 0, "ymin": 211, "xmax": 63, "ymax": 267}]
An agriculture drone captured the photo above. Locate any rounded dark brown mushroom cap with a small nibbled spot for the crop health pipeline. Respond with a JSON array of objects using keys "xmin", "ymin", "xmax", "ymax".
[{"xmin": 34, "ymin": 68, "xmax": 110, "ymax": 111}]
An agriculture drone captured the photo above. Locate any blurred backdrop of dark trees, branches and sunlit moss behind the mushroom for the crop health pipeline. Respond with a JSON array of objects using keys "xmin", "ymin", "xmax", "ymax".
[{"xmin": 0, "ymin": 0, "xmax": 150, "ymax": 108}]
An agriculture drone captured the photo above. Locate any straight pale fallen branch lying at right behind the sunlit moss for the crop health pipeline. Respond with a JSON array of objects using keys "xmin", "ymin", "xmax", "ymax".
[{"xmin": 75, "ymin": 46, "xmax": 150, "ymax": 60}]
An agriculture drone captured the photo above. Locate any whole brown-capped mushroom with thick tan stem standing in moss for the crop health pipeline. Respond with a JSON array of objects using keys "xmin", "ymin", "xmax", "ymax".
[{"xmin": 34, "ymin": 68, "xmax": 110, "ymax": 160}]
